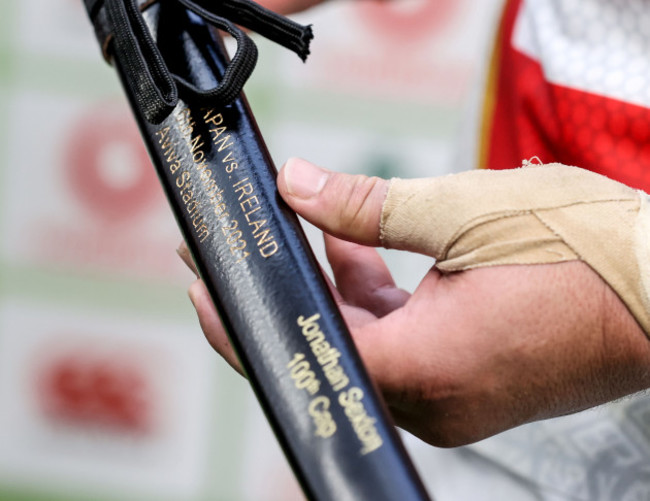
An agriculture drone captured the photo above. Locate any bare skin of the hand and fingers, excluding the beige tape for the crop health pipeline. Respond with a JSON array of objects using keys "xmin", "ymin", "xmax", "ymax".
[{"xmin": 180, "ymin": 160, "xmax": 650, "ymax": 446}]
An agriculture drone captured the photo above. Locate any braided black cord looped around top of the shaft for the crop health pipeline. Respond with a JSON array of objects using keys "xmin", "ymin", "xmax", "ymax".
[{"xmin": 90, "ymin": 0, "xmax": 313, "ymax": 124}]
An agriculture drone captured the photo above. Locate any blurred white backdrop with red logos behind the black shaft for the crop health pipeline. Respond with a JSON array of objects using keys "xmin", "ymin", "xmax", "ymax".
[{"xmin": 0, "ymin": 0, "xmax": 501, "ymax": 501}]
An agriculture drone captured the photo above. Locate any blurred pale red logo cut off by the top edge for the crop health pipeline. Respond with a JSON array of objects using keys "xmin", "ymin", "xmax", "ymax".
[{"xmin": 355, "ymin": 0, "xmax": 461, "ymax": 43}]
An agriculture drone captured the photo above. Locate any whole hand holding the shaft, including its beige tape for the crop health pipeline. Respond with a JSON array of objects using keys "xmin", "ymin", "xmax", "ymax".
[{"xmin": 182, "ymin": 159, "xmax": 650, "ymax": 446}]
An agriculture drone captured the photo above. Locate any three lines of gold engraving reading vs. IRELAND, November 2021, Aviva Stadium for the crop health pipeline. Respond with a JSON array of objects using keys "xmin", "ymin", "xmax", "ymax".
[{"xmin": 156, "ymin": 104, "xmax": 280, "ymax": 263}]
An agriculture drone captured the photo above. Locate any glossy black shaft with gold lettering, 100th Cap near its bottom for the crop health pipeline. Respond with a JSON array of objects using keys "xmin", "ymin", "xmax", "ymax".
[{"xmin": 85, "ymin": 0, "xmax": 429, "ymax": 501}]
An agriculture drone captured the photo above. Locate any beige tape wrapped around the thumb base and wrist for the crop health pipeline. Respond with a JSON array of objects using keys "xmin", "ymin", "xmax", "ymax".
[{"xmin": 380, "ymin": 164, "xmax": 650, "ymax": 334}]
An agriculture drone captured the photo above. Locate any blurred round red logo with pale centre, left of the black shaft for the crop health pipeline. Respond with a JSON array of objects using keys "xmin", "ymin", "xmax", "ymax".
[{"xmin": 65, "ymin": 104, "xmax": 159, "ymax": 222}]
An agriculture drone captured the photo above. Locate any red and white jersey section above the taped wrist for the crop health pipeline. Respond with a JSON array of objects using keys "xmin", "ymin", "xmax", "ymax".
[{"xmin": 479, "ymin": 0, "xmax": 650, "ymax": 191}]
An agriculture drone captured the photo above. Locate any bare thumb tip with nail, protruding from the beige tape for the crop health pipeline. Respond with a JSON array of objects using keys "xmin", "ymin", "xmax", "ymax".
[{"xmin": 278, "ymin": 154, "xmax": 388, "ymax": 247}]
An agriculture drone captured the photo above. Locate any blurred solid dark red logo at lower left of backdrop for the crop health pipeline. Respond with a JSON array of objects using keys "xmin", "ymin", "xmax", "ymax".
[{"xmin": 38, "ymin": 350, "xmax": 153, "ymax": 433}]
